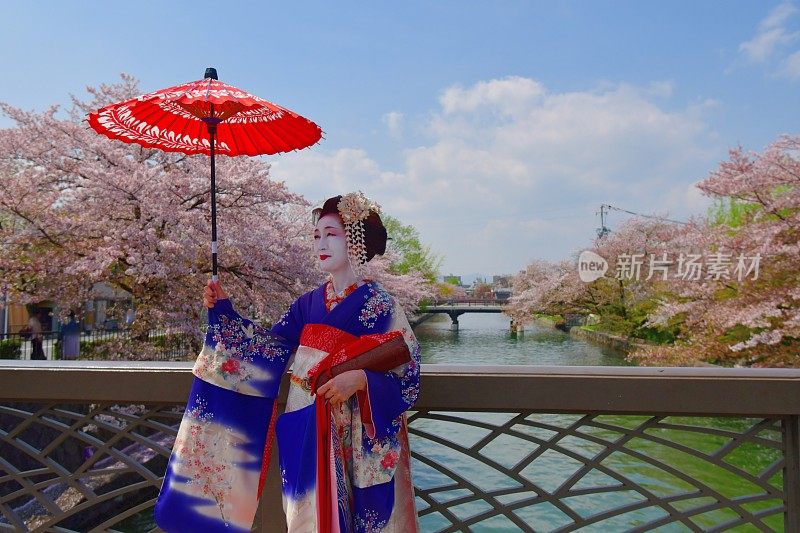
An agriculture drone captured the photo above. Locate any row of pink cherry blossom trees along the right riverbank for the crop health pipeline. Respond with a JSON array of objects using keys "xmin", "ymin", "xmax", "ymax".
[{"xmin": 508, "ymin": 136, "xmax": 800, "ymax": 366}]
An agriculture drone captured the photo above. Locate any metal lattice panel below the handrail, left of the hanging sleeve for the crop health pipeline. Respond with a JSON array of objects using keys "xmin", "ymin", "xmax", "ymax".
[{"xmin": 0, "ymin": 403, "xmax": 183, "ymax": 531}]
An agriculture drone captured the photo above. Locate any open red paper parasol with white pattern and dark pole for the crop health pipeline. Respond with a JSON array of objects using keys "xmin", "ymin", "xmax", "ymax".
[{"xmin": 88, "ymin": 68, "xmax": 322, "ymax": 281}]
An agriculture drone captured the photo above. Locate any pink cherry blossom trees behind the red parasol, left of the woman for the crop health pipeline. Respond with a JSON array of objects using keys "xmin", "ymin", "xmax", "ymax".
[{"xmin": 0, "ymin": 75, "xmax": 320, "ymax": 357}]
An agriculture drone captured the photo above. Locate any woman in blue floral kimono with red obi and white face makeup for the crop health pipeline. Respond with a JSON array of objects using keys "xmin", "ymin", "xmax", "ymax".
[{"xmin": 155, "ymin": 192, "xmax": 420, "ymax": 533}]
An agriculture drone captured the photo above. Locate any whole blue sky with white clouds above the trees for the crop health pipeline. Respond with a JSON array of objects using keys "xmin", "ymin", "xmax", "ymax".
[{"xmin": 0, "ymin": 1, "xmax": 800, "ymax": 275}]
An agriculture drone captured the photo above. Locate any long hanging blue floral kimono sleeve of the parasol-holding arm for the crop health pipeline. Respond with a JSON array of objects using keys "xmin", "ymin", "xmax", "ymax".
[{"xmin": 154, "ymin": 299, "xmax": 299, "ymax": 532}]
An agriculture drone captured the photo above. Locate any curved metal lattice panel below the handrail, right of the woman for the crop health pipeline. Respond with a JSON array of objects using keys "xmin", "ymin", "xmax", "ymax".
[{"xmin": 410, "ymin": 411, "xmax": 786, "ymax": 531}]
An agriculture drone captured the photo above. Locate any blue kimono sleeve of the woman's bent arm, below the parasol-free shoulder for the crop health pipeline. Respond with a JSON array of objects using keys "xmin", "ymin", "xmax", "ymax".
[{"xmin": 358, "ymin": 300, "xmax": 420, "ymax": 439}]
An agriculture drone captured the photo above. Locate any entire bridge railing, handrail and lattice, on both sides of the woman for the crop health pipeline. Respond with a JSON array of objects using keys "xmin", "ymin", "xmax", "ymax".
[{"xmin": 0, "ymin": 361, "xmax": 800, "ymax": 531}]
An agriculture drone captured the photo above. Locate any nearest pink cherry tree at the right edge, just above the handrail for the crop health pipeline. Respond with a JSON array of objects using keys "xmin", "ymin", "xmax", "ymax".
[{"xmin": 634, "ymin": 136, "xmax": 800, "ymax": 366}]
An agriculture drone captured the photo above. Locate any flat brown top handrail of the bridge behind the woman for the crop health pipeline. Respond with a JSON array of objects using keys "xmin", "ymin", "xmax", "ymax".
[{"xmin": 0, "ymin": 360, "xmax": 800, "ymax": 416}]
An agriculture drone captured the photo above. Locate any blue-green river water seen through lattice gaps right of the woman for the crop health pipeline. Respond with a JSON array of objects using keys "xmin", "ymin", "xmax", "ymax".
[{"xmin": 411, "ymin": 413, "xmax": 783, "ymax": 532}]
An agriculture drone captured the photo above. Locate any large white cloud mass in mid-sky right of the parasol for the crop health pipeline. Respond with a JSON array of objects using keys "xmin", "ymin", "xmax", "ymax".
[{"xmin": 273, "ymin": 77, "xmax": 722, "ymax": 275}]
